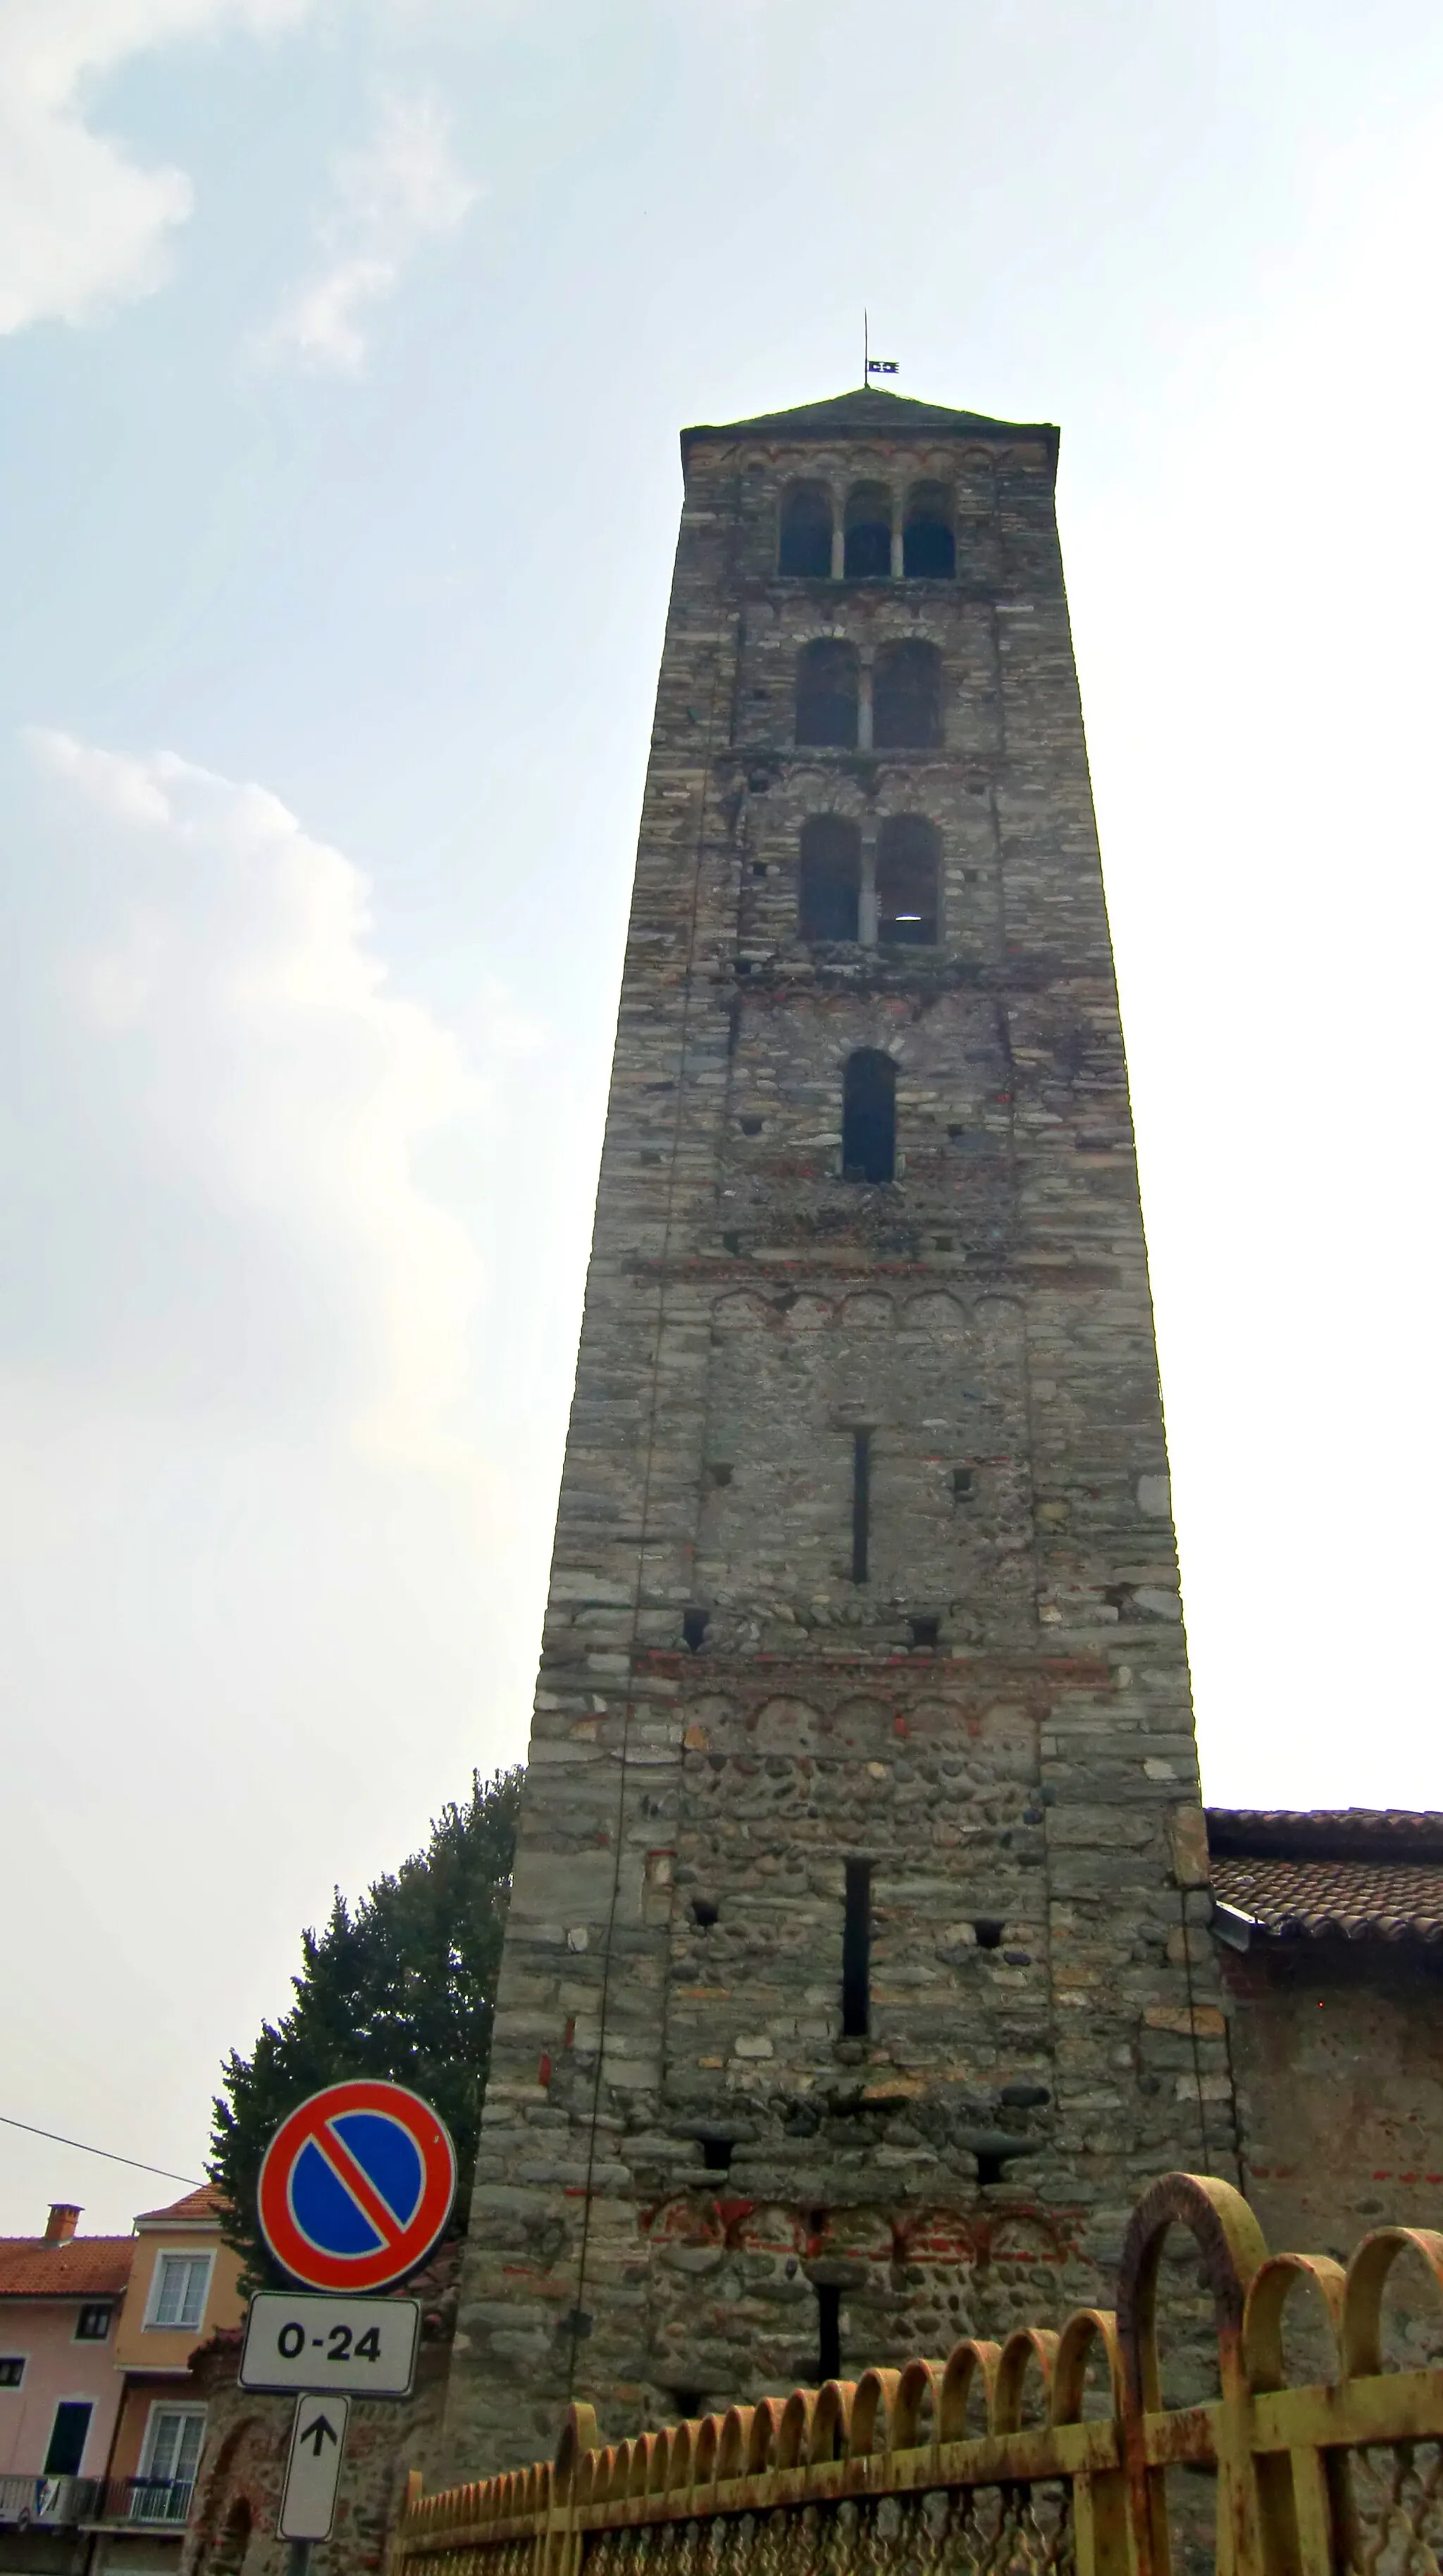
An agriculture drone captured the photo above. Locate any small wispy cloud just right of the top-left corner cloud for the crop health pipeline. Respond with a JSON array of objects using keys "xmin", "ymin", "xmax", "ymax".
[{"xmin": 258, "ymin": 98, "xmax": 477, "ymax": 376}]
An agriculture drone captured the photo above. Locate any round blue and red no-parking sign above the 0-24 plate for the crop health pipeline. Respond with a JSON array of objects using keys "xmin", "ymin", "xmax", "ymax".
[{"xmin": 258, "ymin": 2077, "xmax": 456, "ymax": 2290}]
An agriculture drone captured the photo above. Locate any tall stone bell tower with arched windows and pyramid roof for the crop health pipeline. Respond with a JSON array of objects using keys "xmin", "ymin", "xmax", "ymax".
[{"xmin": 446, "ymin": 392, "xmax": 1234, "ymax": 2478}]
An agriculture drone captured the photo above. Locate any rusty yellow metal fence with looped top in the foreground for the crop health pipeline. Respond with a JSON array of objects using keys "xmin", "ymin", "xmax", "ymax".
[{"xmin": 389, "ymin": 2174, "xmax": 1443, "ymax": 2576}]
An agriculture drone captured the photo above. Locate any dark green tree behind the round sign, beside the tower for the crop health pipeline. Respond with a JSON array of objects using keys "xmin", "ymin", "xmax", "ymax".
[{"xmin": 206, "ymin": 1769, "xmax": 523, "ymax": 2287}]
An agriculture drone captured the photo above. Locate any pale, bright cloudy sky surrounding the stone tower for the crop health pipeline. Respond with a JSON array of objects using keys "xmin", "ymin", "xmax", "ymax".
[{"xmin": 0, "ymin": 0, "xmax": 1443, "ymax": 2234}]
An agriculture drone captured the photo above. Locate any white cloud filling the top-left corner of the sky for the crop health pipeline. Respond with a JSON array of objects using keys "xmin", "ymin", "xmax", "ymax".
[{"xmin": 0, "ymin": 0, "xmax": 309, "ymax": 332}]
